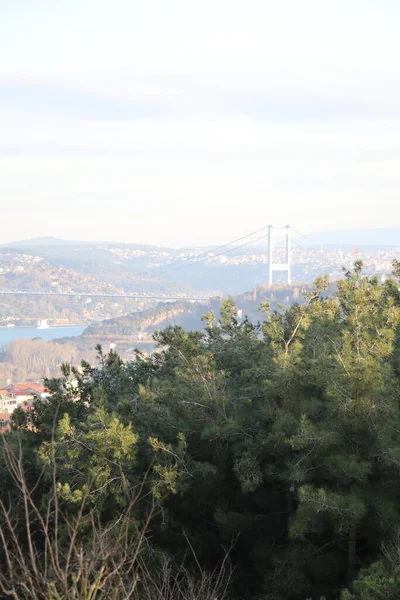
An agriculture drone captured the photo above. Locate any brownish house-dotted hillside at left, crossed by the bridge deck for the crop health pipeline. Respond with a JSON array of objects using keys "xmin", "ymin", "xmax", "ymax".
[{"xmin": 0, "ymin": 246, "xmax": 195, "ymax": 325}]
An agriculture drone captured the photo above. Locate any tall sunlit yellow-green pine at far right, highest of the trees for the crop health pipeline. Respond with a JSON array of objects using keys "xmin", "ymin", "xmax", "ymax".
[{"xmin": 291, "ymin": 263, "xmax": 400, "ymax": 581}]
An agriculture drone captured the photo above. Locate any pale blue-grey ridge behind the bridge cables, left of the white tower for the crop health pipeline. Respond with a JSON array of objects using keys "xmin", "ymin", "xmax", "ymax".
[{"xmin": 0, "ymin": 237, "xmax": 276, "ymax": 295}]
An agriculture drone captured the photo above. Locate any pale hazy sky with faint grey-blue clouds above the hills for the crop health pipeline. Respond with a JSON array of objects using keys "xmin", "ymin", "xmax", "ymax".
[{"xmin": 0, "ymin": 0, "xmax": 400, "ymax": 245}]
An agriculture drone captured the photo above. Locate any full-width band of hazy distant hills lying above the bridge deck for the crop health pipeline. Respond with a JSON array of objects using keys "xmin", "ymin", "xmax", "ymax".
[{"xmin": 0, "ymin": 227, "xmax": 400, "ymax": 302}]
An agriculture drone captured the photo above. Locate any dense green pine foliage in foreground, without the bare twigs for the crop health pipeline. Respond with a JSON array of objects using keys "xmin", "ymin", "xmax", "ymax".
[{"xmin": 2, "ymin": 262, "xmax": 400, "ymax": 600}]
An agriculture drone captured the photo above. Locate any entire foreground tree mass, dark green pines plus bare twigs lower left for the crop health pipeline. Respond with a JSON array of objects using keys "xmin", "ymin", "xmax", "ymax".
[{"xmin": 0, "ymin": 262, "xmax": 400, "ymax": 600}]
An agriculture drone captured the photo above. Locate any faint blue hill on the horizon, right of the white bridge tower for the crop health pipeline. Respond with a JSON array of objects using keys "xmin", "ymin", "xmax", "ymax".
[{"xmin": 304, "ymin": 227, "xmax": 400, "ymax": 247}]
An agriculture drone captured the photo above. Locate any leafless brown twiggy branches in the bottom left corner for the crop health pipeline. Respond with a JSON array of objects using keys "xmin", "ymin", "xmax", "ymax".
[{"xmin": 0, "ymin": 437, "xmax": 229, "ymax": 600}]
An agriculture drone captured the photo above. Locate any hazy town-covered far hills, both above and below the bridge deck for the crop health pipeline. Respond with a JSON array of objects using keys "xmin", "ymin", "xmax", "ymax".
[{"xmin": 0, "ymin": 236, "xmax": 400, "ymax": 326}]
